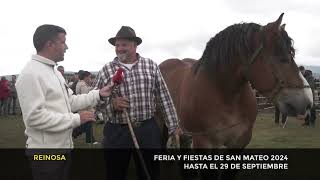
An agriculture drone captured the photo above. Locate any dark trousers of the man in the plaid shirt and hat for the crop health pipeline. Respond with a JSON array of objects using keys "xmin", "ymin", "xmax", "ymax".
[{"xmin": 103, "ymin": 118, "xmax": 161, "ymax": 180}]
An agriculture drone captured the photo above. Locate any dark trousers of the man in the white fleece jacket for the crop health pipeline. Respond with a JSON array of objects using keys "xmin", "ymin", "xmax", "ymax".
[{"xmin": 28, "ymin": 154, "xmax": 71, "ymax": 180}]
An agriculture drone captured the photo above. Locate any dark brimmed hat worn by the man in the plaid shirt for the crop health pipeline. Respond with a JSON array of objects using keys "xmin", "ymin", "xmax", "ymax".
[{"xmin": 108, "ymin": 26, "xmax": 142, "ymax": 45}]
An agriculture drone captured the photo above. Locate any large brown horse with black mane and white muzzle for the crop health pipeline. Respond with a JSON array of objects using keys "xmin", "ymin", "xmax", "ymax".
[{"xmin": 160, "ymin": 14, "xmax": 312, "ymax": 148}]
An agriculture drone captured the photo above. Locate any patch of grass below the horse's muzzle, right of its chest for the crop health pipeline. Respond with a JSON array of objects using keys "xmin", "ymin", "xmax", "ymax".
[{"xmin": 248, "ymin": 113, "xmax": 320, "ymax": 148}]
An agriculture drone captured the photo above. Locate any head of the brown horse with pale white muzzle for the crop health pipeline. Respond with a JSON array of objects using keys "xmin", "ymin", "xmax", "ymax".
[{"xmin": 246, "ymin": 13, "xmax": 313, "ymax": 116}]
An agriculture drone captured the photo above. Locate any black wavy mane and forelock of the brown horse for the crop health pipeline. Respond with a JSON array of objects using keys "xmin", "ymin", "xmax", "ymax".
[{"xmin": 194, "ymin": 23, "xmax": 295, "ymax": 73}]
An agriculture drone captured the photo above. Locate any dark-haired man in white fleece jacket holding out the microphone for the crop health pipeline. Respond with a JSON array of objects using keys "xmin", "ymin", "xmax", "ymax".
[{"xmin": 16, "ymin": 24, "xmax": 111, "ymax": 180}]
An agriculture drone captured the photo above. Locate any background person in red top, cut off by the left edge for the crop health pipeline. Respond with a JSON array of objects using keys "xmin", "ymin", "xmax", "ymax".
[{"xmin": 0, "ymin": 76, "xmax": 10, "ymax": 115}]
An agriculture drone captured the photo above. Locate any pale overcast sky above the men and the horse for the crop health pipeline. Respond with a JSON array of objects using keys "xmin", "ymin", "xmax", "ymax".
[{"xmin": 0, "ymin": 0, "xmax": 320, "ymax": 75}]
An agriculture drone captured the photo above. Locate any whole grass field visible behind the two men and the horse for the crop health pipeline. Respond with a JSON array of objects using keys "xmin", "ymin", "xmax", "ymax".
[{"xmin": 0, "ymin": 111, "xmax": 320, "ymax": 148}]
